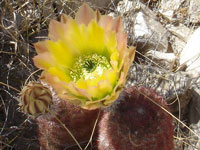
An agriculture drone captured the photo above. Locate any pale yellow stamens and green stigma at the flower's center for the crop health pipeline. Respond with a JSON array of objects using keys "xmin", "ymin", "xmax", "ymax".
[{"xmin": 70, "ymin": 54, "xmax": 111, "ymax": 82}]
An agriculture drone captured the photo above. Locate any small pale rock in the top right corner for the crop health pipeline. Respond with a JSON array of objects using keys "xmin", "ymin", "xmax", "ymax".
[{"xmin": 188, "ymin": 0, "xmax": 200, "ymax": 23}]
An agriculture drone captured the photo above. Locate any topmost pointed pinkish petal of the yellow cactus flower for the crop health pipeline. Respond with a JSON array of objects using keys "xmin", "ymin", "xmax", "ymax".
[{"xmin": 75, "ymin": 3, "xmax": 96, "ymax": 25}]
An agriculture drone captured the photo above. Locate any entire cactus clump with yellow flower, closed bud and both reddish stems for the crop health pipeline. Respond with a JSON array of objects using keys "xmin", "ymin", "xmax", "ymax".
[{"xmin": 18, "ymin": 4, "xmax": 173, "ymax": 150}]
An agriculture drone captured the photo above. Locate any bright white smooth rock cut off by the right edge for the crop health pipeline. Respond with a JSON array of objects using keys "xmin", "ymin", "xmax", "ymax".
[{"xmin": 180, "ymin": 27, "xmax": 200, "ymax": 73}]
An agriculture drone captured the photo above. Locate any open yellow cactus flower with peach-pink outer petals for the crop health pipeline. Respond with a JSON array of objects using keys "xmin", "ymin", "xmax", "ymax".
[{"xmin": 33, "ymin": 4, "xmax": 135, "ymax": 109}]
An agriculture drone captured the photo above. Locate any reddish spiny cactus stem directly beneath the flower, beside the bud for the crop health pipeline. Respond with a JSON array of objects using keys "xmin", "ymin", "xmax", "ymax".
[{"xmin": 37, "ymin": 100, "xmax": 98, "ymax": 150}]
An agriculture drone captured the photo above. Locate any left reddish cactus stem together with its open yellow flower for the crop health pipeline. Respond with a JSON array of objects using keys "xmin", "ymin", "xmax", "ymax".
[{"xmin": 23, "ymin": 4, "xmax": 135, "ymax": 150}]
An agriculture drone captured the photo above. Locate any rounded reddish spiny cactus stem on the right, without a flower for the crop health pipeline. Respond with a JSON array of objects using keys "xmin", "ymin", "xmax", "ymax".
[{"xmin": 97, "ymin": 87, "xmax": 174, "ymax": 150}]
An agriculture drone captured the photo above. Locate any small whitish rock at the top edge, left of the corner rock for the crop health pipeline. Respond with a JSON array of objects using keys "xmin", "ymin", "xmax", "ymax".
[{"xmin": 159, "ymin": 0, "xmax": 184, "ymax": 21}]
